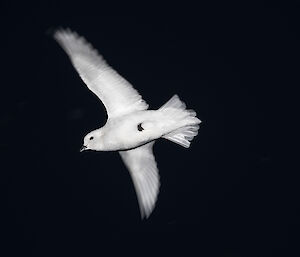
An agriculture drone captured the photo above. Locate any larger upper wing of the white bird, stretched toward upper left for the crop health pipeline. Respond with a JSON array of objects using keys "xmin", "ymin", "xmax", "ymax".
[{"xmin": 54, "ymin": 29, "xmax": 148, "ymax": 118}]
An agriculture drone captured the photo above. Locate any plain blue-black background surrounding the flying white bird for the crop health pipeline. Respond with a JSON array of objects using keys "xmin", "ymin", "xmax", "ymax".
[{"xmin": 0, "ymin": 2, "xmax": 300, "ymax": 256}]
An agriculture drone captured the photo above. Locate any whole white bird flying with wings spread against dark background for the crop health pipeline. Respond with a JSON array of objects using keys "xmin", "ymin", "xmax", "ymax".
[{"xmin": 54, "ymin": 29, "xmax": 201, "ymax": 218}]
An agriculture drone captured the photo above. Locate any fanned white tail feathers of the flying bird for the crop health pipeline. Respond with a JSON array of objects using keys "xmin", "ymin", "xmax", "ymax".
[{"xmin": 159, "ymin": 95, "xmax": 201, "ymax": 148}]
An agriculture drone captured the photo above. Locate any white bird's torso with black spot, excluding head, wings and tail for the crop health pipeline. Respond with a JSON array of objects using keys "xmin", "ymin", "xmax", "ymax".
[{"xmin": 90, "ymin": 106, "xmax": 197, "ymax": 151}]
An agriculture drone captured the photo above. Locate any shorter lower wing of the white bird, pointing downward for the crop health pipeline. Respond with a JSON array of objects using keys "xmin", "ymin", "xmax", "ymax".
[{"xmin": 119, "ymin": 142, "xmax": 160, "ymax": 218}]
